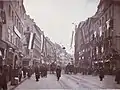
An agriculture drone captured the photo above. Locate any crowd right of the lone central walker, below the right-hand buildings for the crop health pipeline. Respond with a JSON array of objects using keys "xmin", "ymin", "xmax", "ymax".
[{"xmin": 65, "ymin": 63, "xmax": 120, "ymax": 84}]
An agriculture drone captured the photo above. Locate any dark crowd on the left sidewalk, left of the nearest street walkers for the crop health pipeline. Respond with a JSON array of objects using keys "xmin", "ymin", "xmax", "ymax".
[{"xmin": 0, "ymin": 65, "xmax": 34, "ymax": 90}]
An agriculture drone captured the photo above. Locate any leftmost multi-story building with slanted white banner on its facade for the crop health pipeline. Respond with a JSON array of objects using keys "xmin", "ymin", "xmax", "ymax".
[{"xmin": 0, "ymin": 0, "xmax": 26, "ymax": 67}]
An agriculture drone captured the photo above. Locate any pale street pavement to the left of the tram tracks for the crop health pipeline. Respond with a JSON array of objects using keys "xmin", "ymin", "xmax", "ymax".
[{"xmin": 15, "ymin": 74, "xmax": 67, "ymax": 90}]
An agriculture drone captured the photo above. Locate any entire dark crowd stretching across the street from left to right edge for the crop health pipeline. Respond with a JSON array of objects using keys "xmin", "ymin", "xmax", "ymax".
[{"xmin": 0, "ymin": 58, "xmax": 120, "ymax": 90}]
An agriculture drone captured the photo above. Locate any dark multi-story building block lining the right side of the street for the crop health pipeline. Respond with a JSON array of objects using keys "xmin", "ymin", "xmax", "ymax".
[{"xmin": 75, "ymin": 0, "xmax": 120, "ymax": 73}]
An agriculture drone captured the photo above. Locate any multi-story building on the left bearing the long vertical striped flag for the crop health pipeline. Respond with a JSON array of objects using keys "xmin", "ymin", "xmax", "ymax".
[{"xmin": 23, "ymin": 15, "xmax": 42, "ymax": 65}]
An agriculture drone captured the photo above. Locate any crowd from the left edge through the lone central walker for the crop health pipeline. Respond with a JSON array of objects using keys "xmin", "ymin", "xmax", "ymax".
[{"xmin": 0, "ymin": 60, "xmax": 62, "ymax": 90}]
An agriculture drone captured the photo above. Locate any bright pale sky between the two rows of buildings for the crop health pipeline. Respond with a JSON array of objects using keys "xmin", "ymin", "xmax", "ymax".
[{"xmin": 24, "ymin": 0, "xmax": 99, "ymax": 53}]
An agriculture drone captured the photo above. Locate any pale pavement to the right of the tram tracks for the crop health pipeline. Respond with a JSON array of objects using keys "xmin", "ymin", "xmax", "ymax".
[{"xmin": 74, "ymin": 74, "xmax": 120, "ymax": 89}]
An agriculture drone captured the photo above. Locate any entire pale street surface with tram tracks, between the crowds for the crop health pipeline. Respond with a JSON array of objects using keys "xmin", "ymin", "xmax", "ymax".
[{"xmin": 15, "ymin": 74, "xmax": 120, "ymax": 90}]
